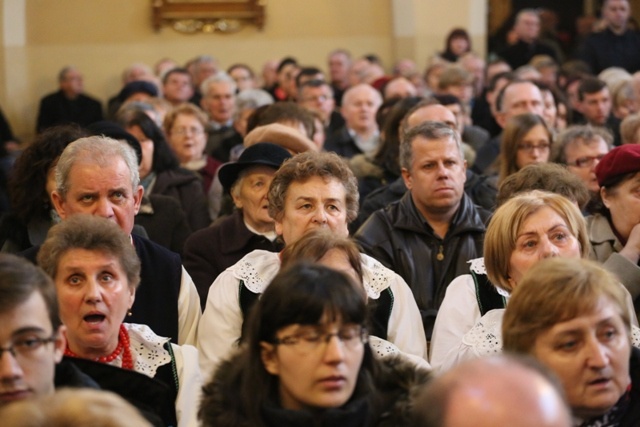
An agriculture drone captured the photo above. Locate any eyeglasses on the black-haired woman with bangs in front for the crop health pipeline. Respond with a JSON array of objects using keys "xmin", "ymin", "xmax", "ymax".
[{"xmin": 272, "ymin": 325, "xmax": 369, "ymax": 353}]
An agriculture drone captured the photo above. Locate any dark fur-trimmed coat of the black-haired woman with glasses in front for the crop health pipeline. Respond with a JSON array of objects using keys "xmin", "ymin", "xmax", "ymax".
[{"xmin": 198, "ymin": 355, "xmax": 430, "ymax": 427}]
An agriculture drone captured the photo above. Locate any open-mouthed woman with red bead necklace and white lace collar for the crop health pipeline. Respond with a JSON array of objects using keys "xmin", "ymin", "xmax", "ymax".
[{"xmin": 38, "ymin": 214, "xmax": 201, "ymax": 426}]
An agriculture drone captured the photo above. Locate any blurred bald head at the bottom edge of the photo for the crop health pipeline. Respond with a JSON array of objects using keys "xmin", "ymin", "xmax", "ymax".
[{"xmin": 415, "ymin": 355, "xmax": 571, "ymax": 427}]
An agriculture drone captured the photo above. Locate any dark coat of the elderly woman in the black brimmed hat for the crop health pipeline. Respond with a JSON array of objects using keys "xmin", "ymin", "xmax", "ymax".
[{"xmin": 183, "ymin": 210, "xmax": 282, "ymax": 310}]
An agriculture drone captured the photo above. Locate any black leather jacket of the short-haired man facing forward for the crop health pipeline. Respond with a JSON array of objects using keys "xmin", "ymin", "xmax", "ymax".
[{"xmin": 355, "ymin": 192, "xmax": 489, "ymax": 339}]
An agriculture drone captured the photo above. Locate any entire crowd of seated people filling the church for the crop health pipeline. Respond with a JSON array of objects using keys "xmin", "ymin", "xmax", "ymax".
[{"xmin": 0, "ymin": 0, "xmax": 640, "ymax": 427}]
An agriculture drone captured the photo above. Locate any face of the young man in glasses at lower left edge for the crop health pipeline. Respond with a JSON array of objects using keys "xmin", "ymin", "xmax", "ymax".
[{"xmin": 0, "ymin": 292, "xmax": 66, "ymax": 406}]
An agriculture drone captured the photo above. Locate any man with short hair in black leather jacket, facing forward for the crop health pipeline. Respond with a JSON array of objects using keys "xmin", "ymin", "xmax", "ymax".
[{"xmin": 356, "ymin": 122, "xmax": 489, "ymax": 339}]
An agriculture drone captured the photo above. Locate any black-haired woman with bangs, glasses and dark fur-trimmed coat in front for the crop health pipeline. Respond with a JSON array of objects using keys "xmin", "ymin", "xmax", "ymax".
[{"xmin": 198, "ymin": 264, "xmax": 430, "ymax": 427}]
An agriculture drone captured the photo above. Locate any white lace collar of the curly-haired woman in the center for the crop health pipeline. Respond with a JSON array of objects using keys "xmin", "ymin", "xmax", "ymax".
[{"xmin": 231, "ymin": 249, "xmax": 396, "ymax": 299}]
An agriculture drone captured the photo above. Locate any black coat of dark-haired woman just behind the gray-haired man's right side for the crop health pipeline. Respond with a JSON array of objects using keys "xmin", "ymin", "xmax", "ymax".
[{"xmin": 151, "ymin": 169, "xmax": 211, "ymax": 231}]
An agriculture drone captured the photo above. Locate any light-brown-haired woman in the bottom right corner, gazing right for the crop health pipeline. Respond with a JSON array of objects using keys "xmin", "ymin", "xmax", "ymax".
[{"xmin": 502, "ymin": 259, "xmax": 640, "ymax": 427}]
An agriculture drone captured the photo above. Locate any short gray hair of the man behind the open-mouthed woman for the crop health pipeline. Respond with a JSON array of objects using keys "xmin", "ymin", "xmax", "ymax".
[{"xmin": 56, "ymin": 136, "xmax": 140, "ymax": 199}]
